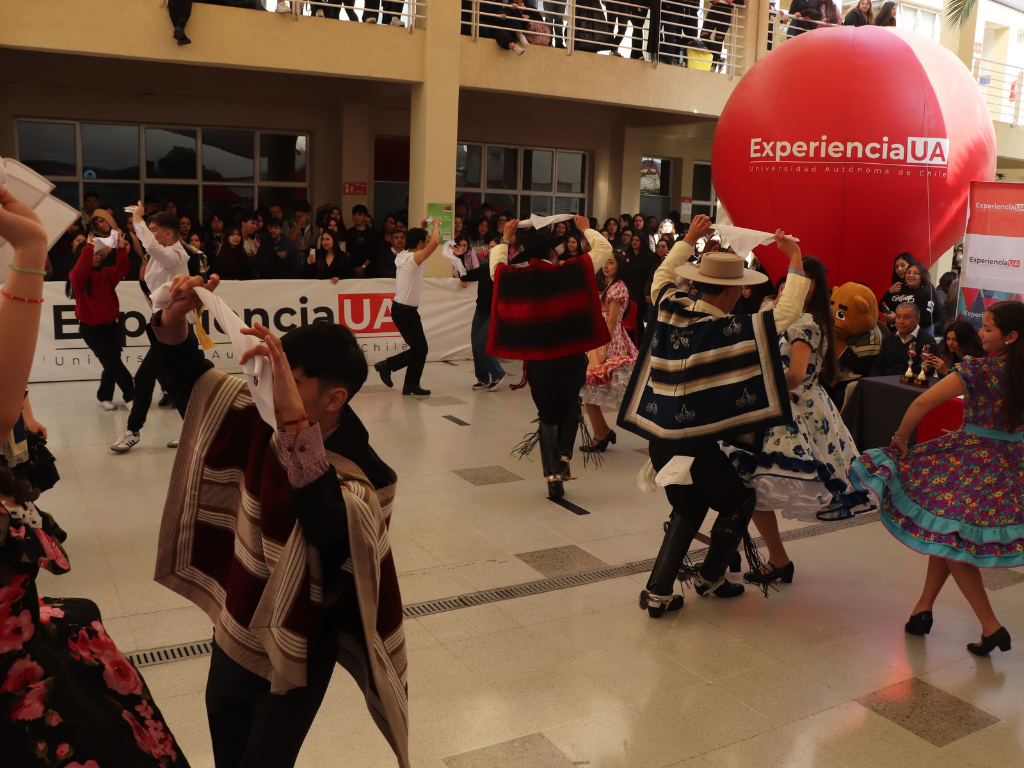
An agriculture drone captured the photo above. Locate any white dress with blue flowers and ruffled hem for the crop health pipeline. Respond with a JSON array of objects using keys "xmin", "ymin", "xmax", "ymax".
[{"xmin": 722, "ymin": 312, "xmax": 871, "ymax": 520}]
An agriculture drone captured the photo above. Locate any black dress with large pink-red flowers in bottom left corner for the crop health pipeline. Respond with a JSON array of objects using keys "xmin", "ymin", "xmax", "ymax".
[{"xmin": 0, "ymin": 502, "xmax": 188, "ymax": 768}]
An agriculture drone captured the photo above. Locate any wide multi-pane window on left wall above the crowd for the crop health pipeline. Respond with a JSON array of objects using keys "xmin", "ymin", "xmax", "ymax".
[{"xmin": 16, "ymin": 120, "xmax": 309, "ymax": 220}]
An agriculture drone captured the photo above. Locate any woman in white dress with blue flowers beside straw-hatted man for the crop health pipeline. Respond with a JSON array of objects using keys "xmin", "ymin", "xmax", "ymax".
[{"xmin": 723, "ymin": 256, "xmax": 868, "ymax": 584}]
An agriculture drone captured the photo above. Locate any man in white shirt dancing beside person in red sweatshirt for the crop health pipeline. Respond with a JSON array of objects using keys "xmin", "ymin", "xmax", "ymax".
[{"xmin": 111, "ymin": 207, "xmax": 188, "ymax": 454}]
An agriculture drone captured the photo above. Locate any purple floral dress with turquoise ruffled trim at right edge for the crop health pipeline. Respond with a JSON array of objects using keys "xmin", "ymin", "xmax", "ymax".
[{"xmin": 853, "ymin": 357, "xmax": 1024, "ymax": 568}]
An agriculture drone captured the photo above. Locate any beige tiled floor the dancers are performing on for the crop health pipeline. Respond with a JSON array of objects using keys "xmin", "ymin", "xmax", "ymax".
[{"xmin": 24, "ymin": 364, "xmax": 1024, "ymax": 768}]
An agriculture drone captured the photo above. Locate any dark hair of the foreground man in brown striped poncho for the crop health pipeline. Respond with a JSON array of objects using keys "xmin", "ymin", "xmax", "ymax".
[{"xmin": 281, "ymin": 322, "xmax": 367, "ymax": 401}]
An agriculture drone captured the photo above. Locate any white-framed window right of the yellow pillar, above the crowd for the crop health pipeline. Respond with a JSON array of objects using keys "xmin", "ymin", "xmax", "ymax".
[{"xmin": 455, "ymin": 143, "xmax": 587, "ymax": 218}]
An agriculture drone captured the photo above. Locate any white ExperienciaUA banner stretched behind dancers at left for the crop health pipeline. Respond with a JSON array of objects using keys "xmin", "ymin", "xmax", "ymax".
[{"xmin": 29, "ymin": 278, "xmax": 476, "ymax": 382}]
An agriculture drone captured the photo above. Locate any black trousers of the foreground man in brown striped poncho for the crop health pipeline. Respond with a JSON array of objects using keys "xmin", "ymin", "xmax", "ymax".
[{"xmin": 206, "ymin": 629, "xmax": 338, "ymax": 768}]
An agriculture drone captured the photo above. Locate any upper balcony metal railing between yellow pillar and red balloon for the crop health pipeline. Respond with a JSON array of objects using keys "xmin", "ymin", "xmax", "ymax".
[{"xmin": 462, "ymin": 0, "xmax": 746, "ymax": 79}]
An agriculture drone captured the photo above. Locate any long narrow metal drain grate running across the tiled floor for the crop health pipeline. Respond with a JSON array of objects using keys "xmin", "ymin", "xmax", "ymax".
[{"xmin": 126, "ymin": 512, "xmax": 882, "ymax": 667}]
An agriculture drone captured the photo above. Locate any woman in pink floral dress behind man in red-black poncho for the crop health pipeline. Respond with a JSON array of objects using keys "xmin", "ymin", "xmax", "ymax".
[{"xmin": 580, "ymin": 253, "xmax": 637, "ymax": 454}]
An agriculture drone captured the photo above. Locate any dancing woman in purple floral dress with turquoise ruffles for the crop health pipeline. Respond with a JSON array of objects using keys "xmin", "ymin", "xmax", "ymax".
[{"xmin": 853, "ymin": 301, "xmax": 1024, "ymax": 656}]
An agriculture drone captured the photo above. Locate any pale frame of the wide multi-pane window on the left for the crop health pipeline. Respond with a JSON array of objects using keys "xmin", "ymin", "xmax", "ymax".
[{"xmin": 14, "ymin": 116, "xmax": 313, "ymax": 221}]
